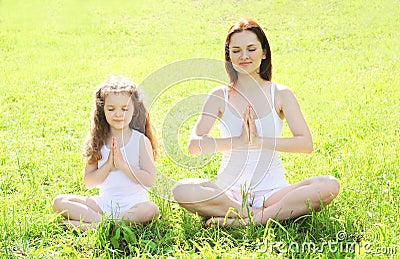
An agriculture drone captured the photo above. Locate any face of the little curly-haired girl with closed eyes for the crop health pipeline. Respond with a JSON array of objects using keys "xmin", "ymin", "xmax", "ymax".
[{"xmin": 104, "ymin": 93, "xmax": 134, "ymax": 130}]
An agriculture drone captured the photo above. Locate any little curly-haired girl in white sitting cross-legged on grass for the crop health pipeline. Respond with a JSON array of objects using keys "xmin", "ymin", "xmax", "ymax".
[{"xmin": 53, "ymin": 77, "xmax": 159, "ymax": 229}]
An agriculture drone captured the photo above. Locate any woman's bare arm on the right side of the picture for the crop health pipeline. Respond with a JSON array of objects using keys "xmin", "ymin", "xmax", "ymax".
[{"xmin": 249, "ymin": 87, "xmax": 313, "ymax": 154}]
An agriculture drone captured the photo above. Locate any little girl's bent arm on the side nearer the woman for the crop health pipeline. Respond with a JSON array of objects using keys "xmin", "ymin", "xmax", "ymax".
[{"xmin": 114, "ymin": 136, "xmax": 157, "ymax": 187}]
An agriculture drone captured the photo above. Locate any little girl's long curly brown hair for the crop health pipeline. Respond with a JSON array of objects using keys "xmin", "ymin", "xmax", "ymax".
[{"xmin": 83, "ymin": 76, "xmax": 158, "ymax": 163}]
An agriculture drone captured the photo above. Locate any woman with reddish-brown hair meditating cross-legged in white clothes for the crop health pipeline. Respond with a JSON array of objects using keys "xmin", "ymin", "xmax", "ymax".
[{"xmin": 173, "ymin": 19, "xmax": 339, "ymax": 225}]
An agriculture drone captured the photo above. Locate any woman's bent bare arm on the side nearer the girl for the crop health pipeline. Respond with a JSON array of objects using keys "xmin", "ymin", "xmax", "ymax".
[{"xmin": 189, "ymin": 87, "xmax": 248, "ymax": 154}]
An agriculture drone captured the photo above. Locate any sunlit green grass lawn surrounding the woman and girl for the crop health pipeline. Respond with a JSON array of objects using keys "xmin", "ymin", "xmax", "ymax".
[{"xmin": 0, "ymin": 0, "xmax": 400, "ymax": 258}]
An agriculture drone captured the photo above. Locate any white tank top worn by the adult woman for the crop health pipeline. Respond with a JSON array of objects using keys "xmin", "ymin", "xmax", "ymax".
[{"xmin": 216, "ymin": 83, "xmax": 288, "ymax": 191}]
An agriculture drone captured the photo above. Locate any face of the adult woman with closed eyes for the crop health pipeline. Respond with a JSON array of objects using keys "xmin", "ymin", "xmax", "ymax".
[{"xmin": 229, "ymin": 30, "xmax": 265, "ymax": 74}]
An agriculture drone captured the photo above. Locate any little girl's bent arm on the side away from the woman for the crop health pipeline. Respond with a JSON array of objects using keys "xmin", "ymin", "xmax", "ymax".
[{"xmin": 84, "ymin": 155, "xmax": 113, "ymax": 189}]
